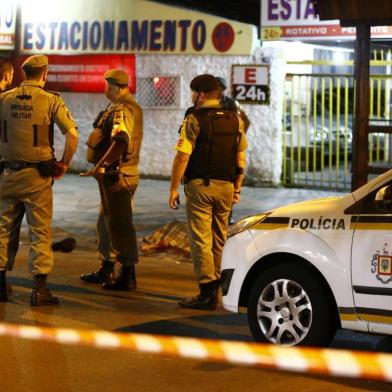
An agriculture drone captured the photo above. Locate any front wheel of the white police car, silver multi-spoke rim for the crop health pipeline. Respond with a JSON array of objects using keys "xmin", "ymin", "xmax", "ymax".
[{"xmin": 248, "ymin": 263, "xmax": 336, "ymax": 346}]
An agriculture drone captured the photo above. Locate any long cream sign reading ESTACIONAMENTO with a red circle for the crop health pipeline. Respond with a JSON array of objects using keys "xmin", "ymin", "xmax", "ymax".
[{"xmin": 21, "ymin": 0, "xmax": 256, "ymax": 54}]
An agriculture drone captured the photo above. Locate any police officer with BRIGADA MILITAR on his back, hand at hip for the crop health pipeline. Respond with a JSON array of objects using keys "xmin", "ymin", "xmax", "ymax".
[{"xmin": 0, "ymin": 55, "xmax": 78, "ymax": 306}]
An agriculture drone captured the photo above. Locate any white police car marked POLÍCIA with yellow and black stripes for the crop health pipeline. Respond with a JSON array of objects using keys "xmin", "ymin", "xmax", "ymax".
[{"xmin": 221, "ymin": 170, "xmax": 392, "ymax": 346}]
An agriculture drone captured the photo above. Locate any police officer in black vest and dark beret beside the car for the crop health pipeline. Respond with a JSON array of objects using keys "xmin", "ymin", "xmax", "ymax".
[{"xmin": 169, "ymin": 74, "xmax": 247, "ymax": 310}]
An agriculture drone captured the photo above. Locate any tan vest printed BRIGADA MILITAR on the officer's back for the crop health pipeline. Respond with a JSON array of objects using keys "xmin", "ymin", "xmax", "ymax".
[{"xmin": 0, "ymin": 87, "xmax": 54, "ymax": 161}]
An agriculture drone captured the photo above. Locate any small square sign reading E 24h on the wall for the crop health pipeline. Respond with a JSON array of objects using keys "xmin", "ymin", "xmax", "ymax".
[{"xmin": 231, "ymin": 64, "xmax": 270, "ymax": 105}]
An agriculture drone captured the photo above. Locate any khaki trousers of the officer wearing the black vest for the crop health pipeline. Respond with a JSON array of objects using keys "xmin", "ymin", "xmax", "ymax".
[{"xmin": 185, "ymin": 179, "xmax": 234, "ymax": 284}]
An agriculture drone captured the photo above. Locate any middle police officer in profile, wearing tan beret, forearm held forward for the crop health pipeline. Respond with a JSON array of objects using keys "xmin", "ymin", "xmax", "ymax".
[{"xmin": 81, "ymin": 69, "xmax": 143, "ymax": 290}]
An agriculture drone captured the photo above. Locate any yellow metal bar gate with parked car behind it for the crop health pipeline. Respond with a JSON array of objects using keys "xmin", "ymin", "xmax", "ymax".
[{"xmin": 282, "ymin": 60, "xmax": 392, "ymax": 190}]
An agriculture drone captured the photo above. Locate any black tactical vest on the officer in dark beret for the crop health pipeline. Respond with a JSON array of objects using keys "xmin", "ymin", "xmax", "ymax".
[{"xmin": 185, "ymin": 108, "xmax": 239, "ymax": 181}]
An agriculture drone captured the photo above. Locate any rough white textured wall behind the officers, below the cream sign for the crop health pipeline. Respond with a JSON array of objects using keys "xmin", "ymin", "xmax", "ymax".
[{"xmin": 56, "ymin": 48, "xmax": 285, "ymax": 185}]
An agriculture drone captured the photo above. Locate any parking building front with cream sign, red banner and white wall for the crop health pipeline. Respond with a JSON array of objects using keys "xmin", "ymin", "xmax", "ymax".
[{"xmin": 3, "ymin": 0, "xmax": 284, "ymax": 185}]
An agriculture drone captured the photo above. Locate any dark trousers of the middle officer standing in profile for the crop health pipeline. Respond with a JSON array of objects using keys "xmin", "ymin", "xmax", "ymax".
[{"xmin": 97, "ymin": 174, "xmax": 139, "ymax": 267}]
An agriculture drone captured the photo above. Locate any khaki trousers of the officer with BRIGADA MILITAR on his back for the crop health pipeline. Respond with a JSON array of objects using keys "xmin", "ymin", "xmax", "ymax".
[{"xmin": 0, "ymin": 168, "xmax": 53, "ymax": 275}]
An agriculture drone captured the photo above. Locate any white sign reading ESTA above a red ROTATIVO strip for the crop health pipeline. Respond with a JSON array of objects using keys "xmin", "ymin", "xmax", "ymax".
[{"xmin": 260, "ymin": 0, "xmax": 392, "ymax": 41}]
